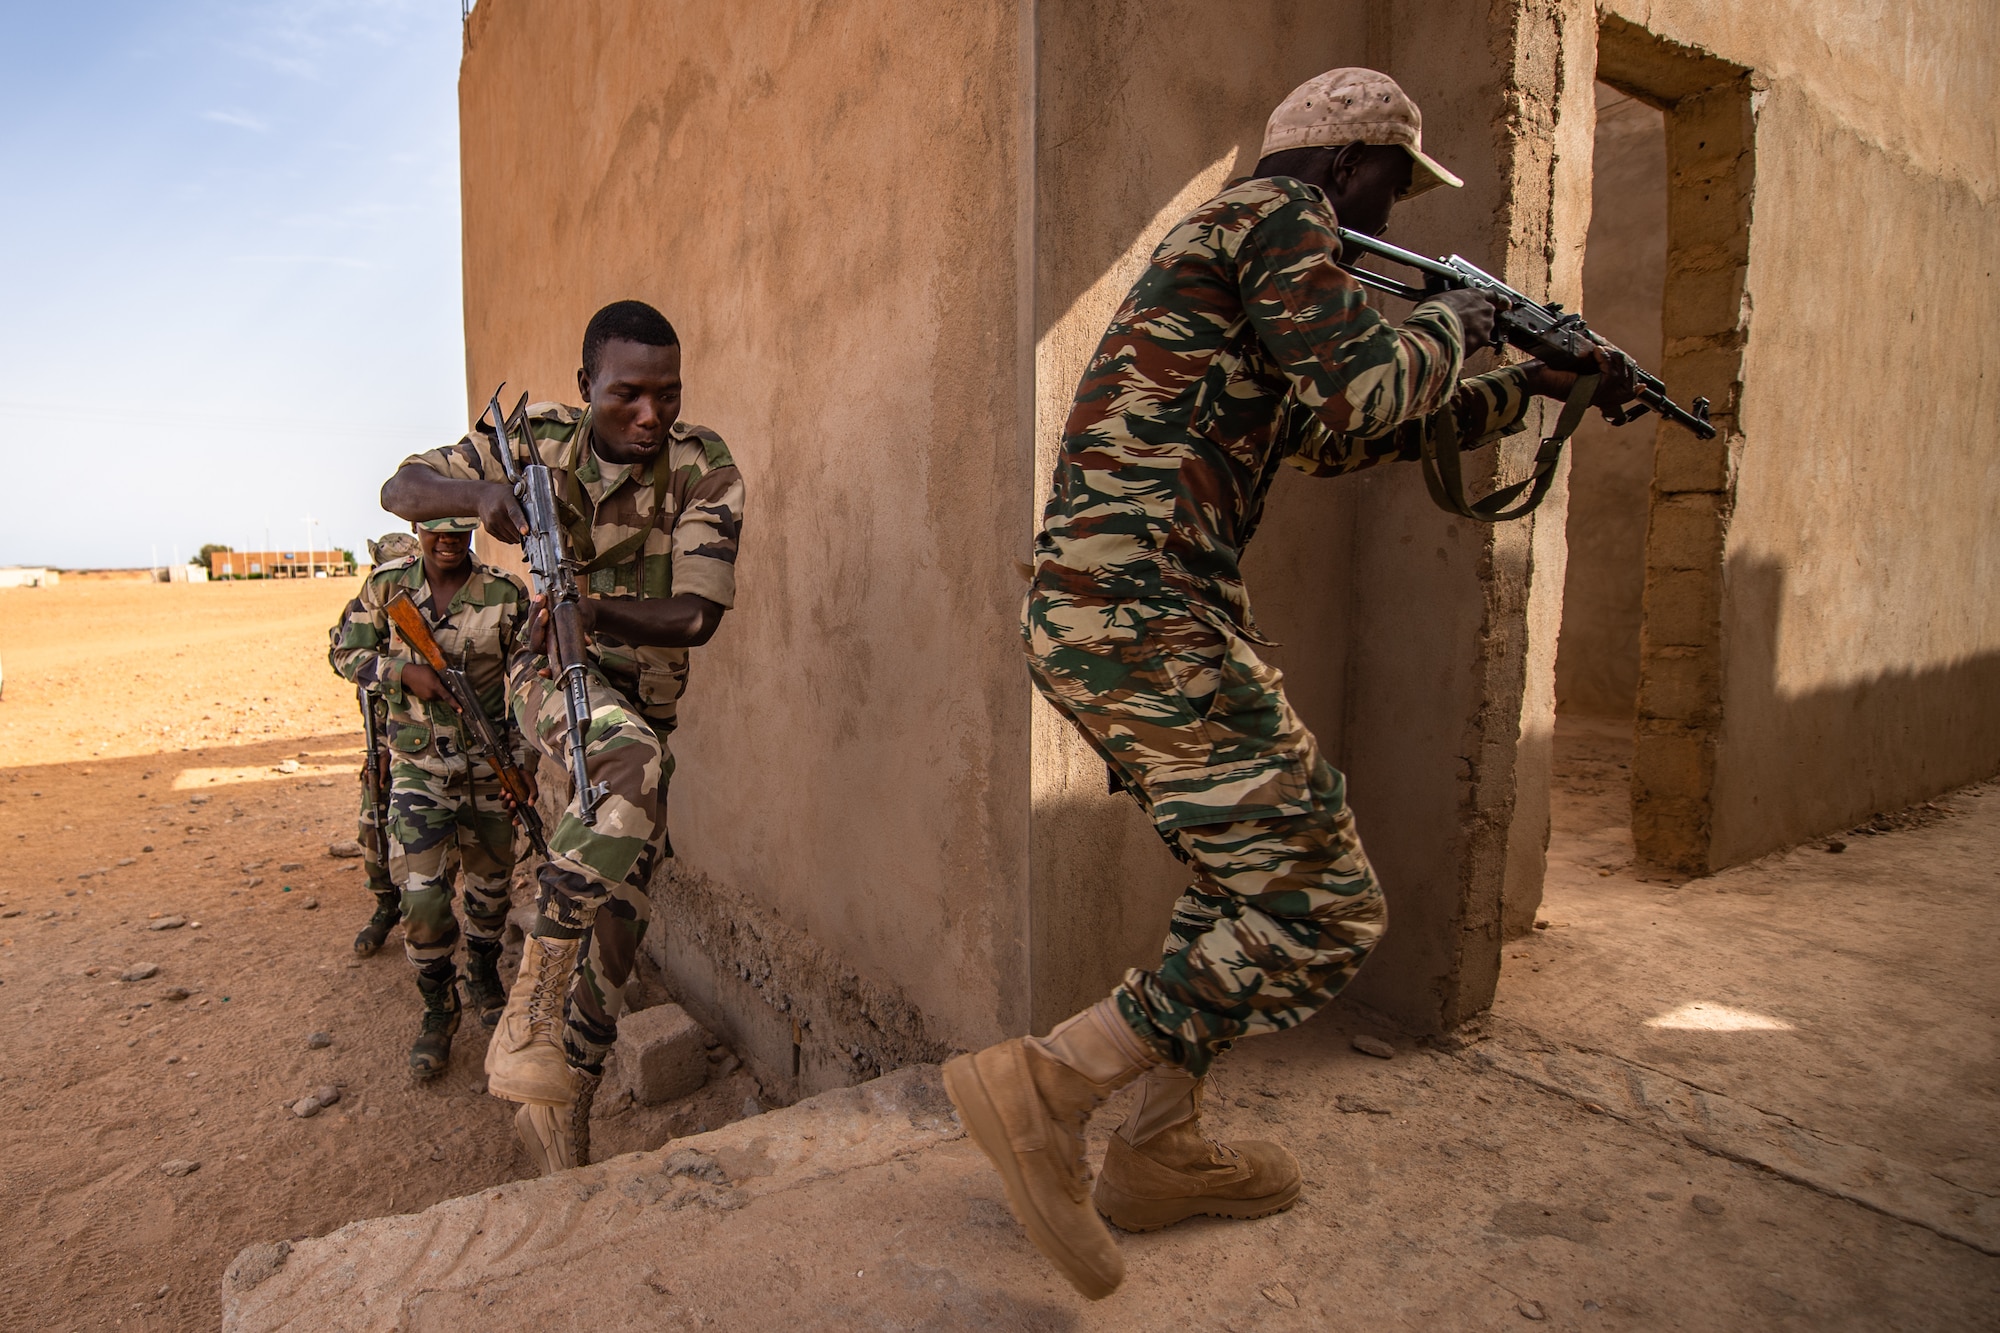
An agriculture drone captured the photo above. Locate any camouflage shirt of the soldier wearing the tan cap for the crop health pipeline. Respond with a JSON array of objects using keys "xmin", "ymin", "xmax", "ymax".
[{"xmin": 1036, "ymin": 176, "xmax": 1528, "ymax": 628}]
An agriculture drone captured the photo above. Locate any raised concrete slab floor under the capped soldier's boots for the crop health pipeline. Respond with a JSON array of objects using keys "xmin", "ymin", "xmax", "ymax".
[{"xmin": 224, "ymin": 721, "xmax": 2000, "ymax": 1333}]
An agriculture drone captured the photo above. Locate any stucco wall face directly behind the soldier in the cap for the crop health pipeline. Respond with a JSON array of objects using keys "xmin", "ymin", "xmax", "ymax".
[{"xmin": 1026, "ymin": 0, "xmax": 1366, "ymax": 1025}]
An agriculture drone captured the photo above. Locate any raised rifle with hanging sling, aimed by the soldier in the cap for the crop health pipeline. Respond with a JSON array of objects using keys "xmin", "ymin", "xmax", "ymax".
[{"xmin": 1340, "ymin": 226, "xmax": 1716, "ymax": 522}]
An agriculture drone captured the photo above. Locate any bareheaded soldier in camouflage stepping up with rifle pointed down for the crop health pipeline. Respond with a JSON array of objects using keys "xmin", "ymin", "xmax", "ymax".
[{"xmin": 382, "ymin": 300, "xmax": 744, "ymax": 1171}]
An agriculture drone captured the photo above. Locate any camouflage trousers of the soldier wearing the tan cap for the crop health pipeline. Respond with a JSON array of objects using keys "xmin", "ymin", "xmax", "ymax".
[{"xmin": 1024, "ymin": 590, "xmax": 1388, "ymax": 1075}]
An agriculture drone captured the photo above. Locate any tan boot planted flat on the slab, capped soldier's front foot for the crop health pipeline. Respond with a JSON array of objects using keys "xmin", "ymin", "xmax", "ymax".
[{"xmin": 1094, "ymin": 1067, "xmax": 1298, "ymax": 1231}]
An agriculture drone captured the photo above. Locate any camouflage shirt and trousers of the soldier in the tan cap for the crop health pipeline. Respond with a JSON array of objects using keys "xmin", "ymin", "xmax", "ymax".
[{"xmin": 1024, "ymin": 178, "xmax": 1528, "ymax": 1075}]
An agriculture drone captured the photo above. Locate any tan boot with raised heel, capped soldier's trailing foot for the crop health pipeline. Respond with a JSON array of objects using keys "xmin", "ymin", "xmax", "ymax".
[{"xmin": 944, "ymin": 999, "xmax": 1160, "ymax": 1301}]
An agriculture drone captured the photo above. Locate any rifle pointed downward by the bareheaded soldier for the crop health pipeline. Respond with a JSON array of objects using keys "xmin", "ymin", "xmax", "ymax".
[{"xmin": 480, "ymin": 384, "xmax": 610, "ymax": 825}]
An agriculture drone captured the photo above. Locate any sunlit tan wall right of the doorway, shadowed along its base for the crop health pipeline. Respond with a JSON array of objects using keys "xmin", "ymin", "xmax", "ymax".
[{"xmin": 1606, "ymin": 0, "xmax": 2000, "ymax": 869}]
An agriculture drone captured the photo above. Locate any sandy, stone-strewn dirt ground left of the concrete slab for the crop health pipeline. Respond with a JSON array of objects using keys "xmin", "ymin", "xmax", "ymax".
[{"xmin": 0, "ymin": 578, "xmax": 758, "ymax": 1329}]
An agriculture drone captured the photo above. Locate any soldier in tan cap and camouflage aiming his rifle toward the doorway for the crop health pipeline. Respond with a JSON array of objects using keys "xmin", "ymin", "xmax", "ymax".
[{"xmin": 944, "ymin": 70, "xmax": 1630, "ymax": 1299}]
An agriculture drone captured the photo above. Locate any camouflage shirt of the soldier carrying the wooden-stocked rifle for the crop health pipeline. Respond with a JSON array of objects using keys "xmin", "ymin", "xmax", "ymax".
[{"xmin": 328, "ymin": 556, "xmax": 528, "ymax": 773}]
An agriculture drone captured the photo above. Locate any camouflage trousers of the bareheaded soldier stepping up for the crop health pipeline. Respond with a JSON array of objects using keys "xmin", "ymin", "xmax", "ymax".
[{"xmin": 508, "ymin": 658, "xmax": 674, "ymax": 1071}]
